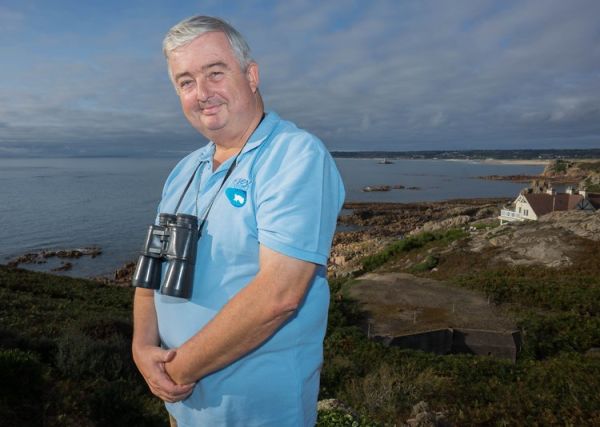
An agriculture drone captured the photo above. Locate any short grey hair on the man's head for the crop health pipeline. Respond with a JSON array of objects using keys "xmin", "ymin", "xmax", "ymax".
[{"xmin": 163, "ymin": 15, "xmax": 253, "ymax": 74}]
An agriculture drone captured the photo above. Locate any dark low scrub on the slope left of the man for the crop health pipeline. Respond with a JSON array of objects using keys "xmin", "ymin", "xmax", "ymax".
[{"xmin": 0, "ymin": 266, "xmax": 168, "ymax": 426}]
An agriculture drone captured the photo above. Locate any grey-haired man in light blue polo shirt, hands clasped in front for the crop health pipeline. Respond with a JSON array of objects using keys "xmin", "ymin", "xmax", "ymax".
[{"xmin": 132, "ymin": 16, "xmax": 344, "ymax": 427}]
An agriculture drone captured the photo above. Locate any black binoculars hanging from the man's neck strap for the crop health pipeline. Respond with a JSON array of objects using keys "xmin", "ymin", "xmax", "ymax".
[{"xmin": 132, "ymin": 213, "xmax": 198, "ymax": 299}]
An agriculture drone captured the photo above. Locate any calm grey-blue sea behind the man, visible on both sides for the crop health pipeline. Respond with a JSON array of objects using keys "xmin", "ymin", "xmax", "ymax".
[{"xmin": 0, "ymin": 158, "xmax": 543, "ymax": 277}]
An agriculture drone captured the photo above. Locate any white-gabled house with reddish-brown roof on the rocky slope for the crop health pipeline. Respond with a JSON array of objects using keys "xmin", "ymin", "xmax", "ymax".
[{"xmin": 499, "ymin": 181, "xmax": 600, "ymax": 224}]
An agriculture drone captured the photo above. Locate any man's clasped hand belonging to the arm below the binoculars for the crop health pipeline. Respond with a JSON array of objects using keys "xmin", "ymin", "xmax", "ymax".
[{"xmin": 133, "ymin": 345, "xmax": 195, "ymax": 403}]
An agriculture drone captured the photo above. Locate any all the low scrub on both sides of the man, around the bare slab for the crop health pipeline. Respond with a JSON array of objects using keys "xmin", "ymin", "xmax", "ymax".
[{"xmin": 0, "ymin": 226, "xmax": 600, "ymax": 427}]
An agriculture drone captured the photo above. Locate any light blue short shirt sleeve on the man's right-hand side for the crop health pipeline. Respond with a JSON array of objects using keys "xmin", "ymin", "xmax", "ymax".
[{"xmin": 254, "ymin": 134, "xmax": 344, "ymax": 265}]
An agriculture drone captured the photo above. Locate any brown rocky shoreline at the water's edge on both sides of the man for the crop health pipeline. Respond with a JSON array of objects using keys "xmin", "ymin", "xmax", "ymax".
[{"xmin": 2, "ymin": 198, "xmax": 511, "ymax": 286}]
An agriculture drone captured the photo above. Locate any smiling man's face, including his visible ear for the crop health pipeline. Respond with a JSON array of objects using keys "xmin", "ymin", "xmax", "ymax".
[{"xmin": 168, "ymin": 32, "xmax": 258, "ymax": 141}]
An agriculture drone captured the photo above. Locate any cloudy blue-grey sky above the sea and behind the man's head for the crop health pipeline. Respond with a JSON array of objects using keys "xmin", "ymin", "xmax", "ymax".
[{"xmin": 0, "ymin": 0, "xmax": 600, "ymax": 157}]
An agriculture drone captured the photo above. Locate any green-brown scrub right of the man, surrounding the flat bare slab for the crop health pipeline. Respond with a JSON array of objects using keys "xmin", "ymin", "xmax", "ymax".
[{"xmin": 321, "ymin": 231, "xmax": 600, "ymax": 426}]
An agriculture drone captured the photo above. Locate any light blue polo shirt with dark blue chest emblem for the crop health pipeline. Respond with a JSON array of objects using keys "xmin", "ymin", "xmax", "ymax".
[{"xmin": 155, "ymin": 112, "xmax": 344, "ymax": 427}]
